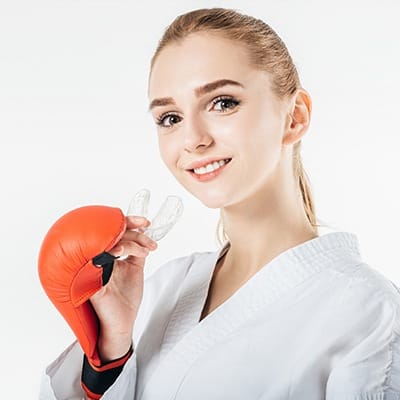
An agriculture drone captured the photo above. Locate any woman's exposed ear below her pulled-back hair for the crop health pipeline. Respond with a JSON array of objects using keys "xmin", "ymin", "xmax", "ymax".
[{"xmin": 282, "ymin": 88, "xmax": 312, "ymax": 145}]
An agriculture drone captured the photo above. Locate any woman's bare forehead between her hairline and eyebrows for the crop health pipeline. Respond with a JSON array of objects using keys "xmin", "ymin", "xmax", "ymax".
[{"xmin": 148, "ymin": 33, "xmax": 261, "ymax": 99}]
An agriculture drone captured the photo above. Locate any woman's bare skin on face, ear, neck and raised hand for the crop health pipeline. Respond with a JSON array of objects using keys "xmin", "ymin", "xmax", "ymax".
[{"xmin": 91, "ymin": 33, "xmax": 316, "ymax": 372}]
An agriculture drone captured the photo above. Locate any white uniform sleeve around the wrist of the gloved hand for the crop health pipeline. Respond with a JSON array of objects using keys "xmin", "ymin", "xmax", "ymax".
[{"xmin": 39, "ymin": 341, "xmax": 137, "ymax": 400}]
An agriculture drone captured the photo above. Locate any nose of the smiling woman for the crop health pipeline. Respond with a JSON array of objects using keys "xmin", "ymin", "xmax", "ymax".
[{"xmin": 183, "ymin": 114, "xmax": 214, "ymax": 153}]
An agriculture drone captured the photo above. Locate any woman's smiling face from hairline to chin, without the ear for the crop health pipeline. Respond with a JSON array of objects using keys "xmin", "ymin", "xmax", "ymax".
[{"xmin": 149, "ymin": 33, "xmax": 287, "ymax": 208}]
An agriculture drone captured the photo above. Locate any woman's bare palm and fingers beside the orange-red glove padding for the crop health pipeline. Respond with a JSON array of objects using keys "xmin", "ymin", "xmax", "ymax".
[{"xmin": 90, "ymin": 216, "xmax": 157, "ymax": 362}]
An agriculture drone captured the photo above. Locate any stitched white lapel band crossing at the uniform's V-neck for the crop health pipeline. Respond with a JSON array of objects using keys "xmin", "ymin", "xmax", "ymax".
[{"xmin": 138, "ymin": 232, "xmax": 361, "ymax": 400}]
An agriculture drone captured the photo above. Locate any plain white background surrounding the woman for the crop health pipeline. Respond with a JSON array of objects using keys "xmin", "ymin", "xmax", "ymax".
[{"xmin": 0, "ymin": 0, "xmax": 400, "ymax": 399}]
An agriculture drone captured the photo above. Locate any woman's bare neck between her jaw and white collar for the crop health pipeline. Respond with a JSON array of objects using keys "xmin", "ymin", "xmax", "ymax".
[{"xmin": 220, "ymin": 171, "xmax": 318, "ymax": 279}]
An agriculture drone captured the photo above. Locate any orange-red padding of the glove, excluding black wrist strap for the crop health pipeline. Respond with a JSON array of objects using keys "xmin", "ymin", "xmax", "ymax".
[{"xmin": 38, "ymin": 206, "xmax": 126, "ymax": 366}]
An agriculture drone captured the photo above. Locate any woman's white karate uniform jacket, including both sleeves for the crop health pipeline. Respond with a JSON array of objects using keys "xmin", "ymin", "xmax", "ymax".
[{"xmin": 40, "ymin": 232, "xmax": 400, "ymax": 400}]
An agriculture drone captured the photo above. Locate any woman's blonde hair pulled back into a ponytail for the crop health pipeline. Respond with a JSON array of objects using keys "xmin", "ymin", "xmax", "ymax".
[{"xmin": 150, "ymin": 7, "xmax": 321, "ymax": 244}]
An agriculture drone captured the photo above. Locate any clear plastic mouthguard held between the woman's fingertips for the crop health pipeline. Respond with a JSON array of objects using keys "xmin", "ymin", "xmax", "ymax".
[{"xmin": 127, "ymin": 189, "xmax": 183, "ymax": 241}]
